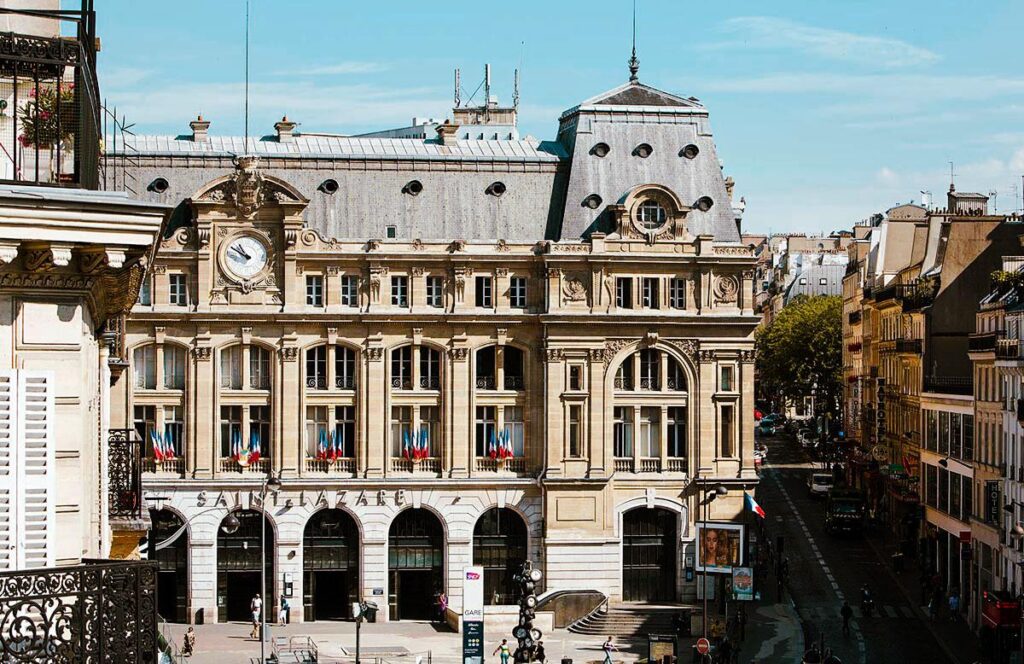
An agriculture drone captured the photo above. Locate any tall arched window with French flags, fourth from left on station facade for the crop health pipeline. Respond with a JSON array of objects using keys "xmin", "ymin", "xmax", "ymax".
[{"xmin": 388, "ymin": 344, "xmax": 443, "ymax": 472}]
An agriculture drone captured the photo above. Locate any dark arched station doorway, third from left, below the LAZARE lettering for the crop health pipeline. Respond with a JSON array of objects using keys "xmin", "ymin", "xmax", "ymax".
[{"xmin": 302, "ymin": 509, "xmax": 359, "ymax": 620}]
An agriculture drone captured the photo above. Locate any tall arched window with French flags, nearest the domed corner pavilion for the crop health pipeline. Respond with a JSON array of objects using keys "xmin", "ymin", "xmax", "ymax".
[{"xmin": 473, "ymin": 345, "xmax": 528, "ymax": 472}]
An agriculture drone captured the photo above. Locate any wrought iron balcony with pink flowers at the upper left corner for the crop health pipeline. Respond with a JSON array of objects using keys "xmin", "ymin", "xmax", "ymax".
[{"xmin": 0, "ymin": 7, "xmax": 101, "ymax": 190}]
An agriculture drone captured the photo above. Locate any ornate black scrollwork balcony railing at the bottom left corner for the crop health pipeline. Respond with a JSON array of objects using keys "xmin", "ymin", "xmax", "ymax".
[{"xmin": 0, "ymin": 561, "xmax": 158, "ymax": 664}]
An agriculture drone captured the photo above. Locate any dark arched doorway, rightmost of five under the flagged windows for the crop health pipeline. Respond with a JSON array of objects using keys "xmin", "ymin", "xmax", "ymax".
[{"xmin": 473, "ymin": 507, "xmax": 526, "ymax": 605}]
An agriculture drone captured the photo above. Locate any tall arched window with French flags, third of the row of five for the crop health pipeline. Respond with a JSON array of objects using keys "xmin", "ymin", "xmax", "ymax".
[{"xmin": 305, "ymin": 344, "xmax": 356, "ymax": 474}]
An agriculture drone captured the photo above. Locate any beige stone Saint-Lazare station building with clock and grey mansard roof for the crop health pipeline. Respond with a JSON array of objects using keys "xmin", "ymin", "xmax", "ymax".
[{"xmin": 112, "ymin": 71, "xmax": 759, "ymax": 621}]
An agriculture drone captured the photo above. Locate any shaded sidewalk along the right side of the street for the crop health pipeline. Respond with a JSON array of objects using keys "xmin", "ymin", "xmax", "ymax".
[{"xmin": 865, "ymin": 531, "xmax": 985, "ymax": 663}]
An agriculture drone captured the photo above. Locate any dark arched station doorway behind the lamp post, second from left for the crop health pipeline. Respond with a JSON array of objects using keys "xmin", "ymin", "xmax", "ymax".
[{"xmin": 217, "ymin": 509, "xmax": 276, "ymax": 622}]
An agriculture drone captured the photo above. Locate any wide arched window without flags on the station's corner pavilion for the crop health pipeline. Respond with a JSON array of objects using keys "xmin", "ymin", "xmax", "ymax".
[{"xmin": 612, "ymin": 348, "xmax": 689, "ymax": 472}]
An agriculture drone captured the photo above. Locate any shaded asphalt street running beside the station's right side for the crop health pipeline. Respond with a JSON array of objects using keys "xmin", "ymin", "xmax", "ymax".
[{"xmin": 759, "ymin": 433, "xmax": 975, "ymax": 664}]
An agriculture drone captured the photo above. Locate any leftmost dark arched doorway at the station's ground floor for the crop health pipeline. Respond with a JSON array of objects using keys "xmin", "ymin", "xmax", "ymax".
[{"xmin": 150, "ymin": 509, "xmax": 188, "ymax": 623}]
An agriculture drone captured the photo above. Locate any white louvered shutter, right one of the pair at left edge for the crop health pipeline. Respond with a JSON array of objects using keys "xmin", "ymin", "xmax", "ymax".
[{"xmin": 15, "ymin": 370, "xmax": 56, "ymax": 569}]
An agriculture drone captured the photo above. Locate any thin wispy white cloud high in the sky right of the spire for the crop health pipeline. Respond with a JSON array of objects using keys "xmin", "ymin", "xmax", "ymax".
[{"xmin": 710, "ymin": 16, "xmax": 940, "ymax": 69}]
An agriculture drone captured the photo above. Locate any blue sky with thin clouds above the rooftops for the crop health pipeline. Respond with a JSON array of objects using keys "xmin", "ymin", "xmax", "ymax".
[{"xmin": 96, "ymin": 0, "xmax": 1024, "ymax": 233}]
